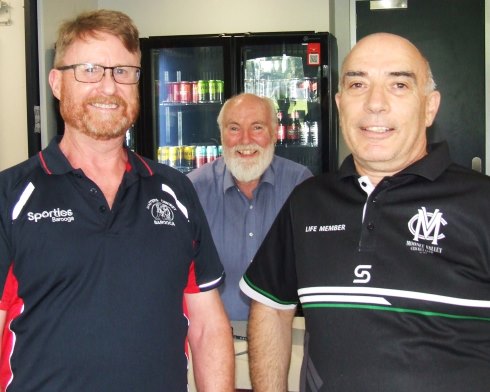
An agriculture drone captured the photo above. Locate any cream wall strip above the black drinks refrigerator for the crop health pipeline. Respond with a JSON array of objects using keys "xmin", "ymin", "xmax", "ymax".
[{"xmin": 98, "ymin": 0, "xmax": 330, "ymax": 37}]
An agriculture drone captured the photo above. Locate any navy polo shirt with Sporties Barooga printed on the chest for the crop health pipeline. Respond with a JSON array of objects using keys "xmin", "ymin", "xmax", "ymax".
[{"xmin": 0, "ymin": 136, "xmax": 223, "ymax": 392}]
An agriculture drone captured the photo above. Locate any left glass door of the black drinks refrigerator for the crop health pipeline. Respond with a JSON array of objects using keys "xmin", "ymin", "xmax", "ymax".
[{"xmin": 151, "ymin": 46, "xmax": 225, "ymax": 172}]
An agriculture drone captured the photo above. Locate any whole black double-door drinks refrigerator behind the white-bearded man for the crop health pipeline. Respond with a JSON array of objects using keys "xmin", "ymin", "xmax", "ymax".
[{"xmin": 138, "ymin": 32, "xmax": 338, "ymax": 174}]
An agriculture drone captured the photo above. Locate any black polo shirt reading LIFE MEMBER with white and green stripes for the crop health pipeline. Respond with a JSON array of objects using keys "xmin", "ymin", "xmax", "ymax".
[{"xmin": 240, "ymin": 144, "xmax": 490, "ymax": 392}]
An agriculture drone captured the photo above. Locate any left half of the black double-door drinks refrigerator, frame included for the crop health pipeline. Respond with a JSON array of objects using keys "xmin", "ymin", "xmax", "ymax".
[{"xmin": 138, "ymin": 35, "xmax": 235, "ymax": 173}]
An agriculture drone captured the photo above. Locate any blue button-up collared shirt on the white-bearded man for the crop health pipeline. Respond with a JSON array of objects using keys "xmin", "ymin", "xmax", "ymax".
[{"xmin": 188, "ymin": 156, "xmax": 312, "ymax": 320}]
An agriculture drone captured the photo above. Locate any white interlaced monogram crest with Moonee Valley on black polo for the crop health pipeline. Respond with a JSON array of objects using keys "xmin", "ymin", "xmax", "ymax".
[{"xmin": 407, "ymin": 207, "xmax": 447, "ymax": 253}]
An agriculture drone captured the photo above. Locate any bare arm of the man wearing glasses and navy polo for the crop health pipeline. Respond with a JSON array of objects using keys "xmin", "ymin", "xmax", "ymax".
[{"xmin": 185, "ymin": 289, "xmax": 235, "ymax": 392}]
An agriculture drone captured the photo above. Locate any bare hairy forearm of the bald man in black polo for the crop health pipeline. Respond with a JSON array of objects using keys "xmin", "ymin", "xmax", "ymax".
[{"xmin": 248, "ymin": 300, "xmax": 296, "ymax": 392}]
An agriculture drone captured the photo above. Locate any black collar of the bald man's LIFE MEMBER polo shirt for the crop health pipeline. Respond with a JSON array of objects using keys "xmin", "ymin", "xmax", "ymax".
[{"xmin": 339, "ymin": 142, "xmax": 452, "ymax": 181}]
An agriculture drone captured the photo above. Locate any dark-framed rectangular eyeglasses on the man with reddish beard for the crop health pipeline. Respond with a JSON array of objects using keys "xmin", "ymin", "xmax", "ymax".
[{"xmin": 56, "ymin": 63, "xmax": 141, "ymax": 84}]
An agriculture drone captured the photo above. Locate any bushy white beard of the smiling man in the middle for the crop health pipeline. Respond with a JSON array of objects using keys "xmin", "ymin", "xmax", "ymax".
[{"xmin": 223, "ymin": 144, "xmax": 274, "ymax": 182}]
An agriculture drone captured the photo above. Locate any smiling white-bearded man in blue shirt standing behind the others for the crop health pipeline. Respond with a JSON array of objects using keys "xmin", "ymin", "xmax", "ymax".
[{"xmin": 188, "ymin": 94, "xmax": 312, "ymax": 321}]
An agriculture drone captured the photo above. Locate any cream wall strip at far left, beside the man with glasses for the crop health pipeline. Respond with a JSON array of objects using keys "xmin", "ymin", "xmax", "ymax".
[{"xmin": 0, "ymin": 0, "xmax": 27, "ymax": 169}]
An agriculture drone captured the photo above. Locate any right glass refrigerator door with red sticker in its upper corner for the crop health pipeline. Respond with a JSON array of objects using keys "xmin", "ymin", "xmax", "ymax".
[{"xmin": 240, "ymin": 36, "xmax": 328, "ymax": 174}]
